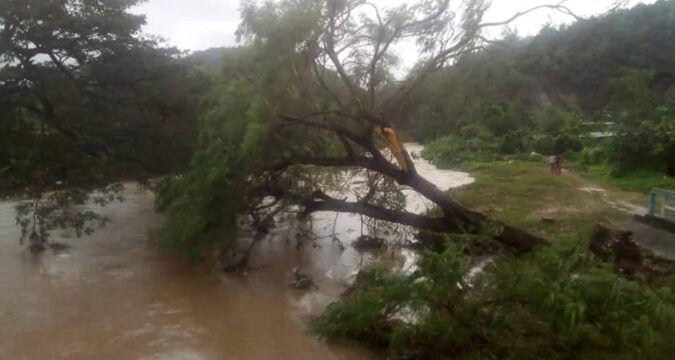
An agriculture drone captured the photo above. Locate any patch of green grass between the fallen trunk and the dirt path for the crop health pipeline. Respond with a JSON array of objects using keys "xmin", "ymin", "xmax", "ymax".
[{"xmin": 451, "ymin": 160, "xmax": 628, "ymax": 240}]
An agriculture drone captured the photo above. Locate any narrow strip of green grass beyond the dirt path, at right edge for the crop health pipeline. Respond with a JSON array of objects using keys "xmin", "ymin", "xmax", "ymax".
[{"xmin": 573, "ymin": 164, "xmax": 675, "ymax": 194}]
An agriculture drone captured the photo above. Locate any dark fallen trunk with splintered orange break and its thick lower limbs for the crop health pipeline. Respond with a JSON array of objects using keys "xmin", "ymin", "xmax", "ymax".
[{"xmin": 278, "ymin": 116, "xmax": 548, "ymax": 252}]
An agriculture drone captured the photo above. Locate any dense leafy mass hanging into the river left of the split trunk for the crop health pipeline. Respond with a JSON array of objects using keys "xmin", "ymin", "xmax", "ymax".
[{"xmin": 157, "ymin": 31, "xmax": 335, "ymax": 258}]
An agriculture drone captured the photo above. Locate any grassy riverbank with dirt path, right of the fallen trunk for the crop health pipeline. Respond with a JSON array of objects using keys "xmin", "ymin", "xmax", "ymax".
[{"xmin": 450, "ymin": 160, "xmax": 675, "ymax": 259}]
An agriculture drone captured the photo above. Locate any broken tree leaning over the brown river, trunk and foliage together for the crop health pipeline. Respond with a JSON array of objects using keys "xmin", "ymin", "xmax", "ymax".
[{"xmin": 160, "ymin": 0, "xmax": 572, "ymax": 251}]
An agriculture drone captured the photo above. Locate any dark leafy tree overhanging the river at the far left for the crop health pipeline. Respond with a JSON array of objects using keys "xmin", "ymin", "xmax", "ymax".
[{"xmin": 0, "ymin": 0, "xmax": 206, "ymax": 249}]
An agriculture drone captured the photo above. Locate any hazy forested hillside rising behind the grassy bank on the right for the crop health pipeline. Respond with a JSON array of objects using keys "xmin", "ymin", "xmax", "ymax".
[{"xmin": 406, "ymin": 1, "xmax": 675, "ymax": 174}]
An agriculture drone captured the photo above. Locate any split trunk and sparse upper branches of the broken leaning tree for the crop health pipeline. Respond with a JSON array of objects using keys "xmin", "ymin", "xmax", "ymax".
[{"xmin": 241, "ymin": 0, "xmax": 588, "ymax": 251}]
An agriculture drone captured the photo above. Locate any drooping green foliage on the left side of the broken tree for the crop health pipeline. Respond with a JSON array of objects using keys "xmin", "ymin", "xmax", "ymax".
[{"xmin": 157, "ymin": 2, "xmax": 338, "ymax": 257}]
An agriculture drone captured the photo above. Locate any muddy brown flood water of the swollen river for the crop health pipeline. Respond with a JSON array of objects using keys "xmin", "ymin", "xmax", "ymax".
[{"xmin": 0, "ymin": 144, "xmax": 472, "ymax": 360}]
